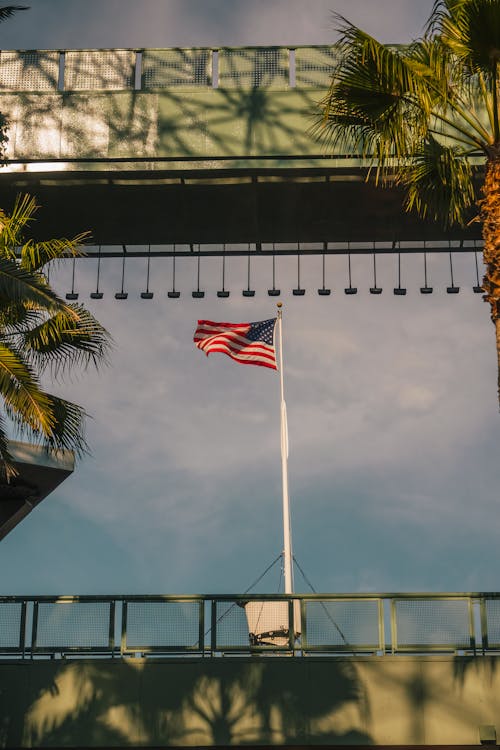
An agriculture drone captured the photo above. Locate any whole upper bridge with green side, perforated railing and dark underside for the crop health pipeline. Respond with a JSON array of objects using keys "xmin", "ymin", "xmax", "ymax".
[{"xmin": 0, "ymin": 47, "xmax": 481, "ymax": 254}]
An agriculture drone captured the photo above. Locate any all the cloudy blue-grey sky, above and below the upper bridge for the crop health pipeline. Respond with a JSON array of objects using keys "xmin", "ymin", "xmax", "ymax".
[{"xmin": 0, "ymin": 0, "xmax": 500, "ymax": 594}]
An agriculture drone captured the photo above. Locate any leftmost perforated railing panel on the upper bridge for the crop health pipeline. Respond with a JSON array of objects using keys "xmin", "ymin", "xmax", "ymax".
[{"xmin": 0, "ymin": 50, "xmax": 59, "ymax": 91}]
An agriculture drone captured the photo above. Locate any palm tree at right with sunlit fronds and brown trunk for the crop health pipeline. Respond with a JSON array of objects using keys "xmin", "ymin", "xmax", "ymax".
[{"xmin": 313, "ymin": 0, "xmax": 500, "ymax": 412}]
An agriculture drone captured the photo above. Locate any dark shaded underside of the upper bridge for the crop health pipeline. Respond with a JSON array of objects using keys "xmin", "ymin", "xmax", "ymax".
[{"xmin": 0, "ymin": 164, "xmax": 481, "ymax": 245}]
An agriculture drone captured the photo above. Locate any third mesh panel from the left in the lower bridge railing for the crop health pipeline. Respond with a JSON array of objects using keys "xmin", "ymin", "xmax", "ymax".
[{"xmin": 123, "ymin": 601, "xmax": 203, "ymax": 651}]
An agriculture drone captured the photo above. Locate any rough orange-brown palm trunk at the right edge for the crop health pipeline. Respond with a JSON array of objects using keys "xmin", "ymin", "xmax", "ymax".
[{"xmin": 479, "ymin": 157, "xmax": 500, "ymax": 409}]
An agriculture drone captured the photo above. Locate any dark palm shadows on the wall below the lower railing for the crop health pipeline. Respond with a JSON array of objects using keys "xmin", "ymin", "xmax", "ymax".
[{"xmin": 0, "ymin": 658, "xmax": 373, "ymax": 747}]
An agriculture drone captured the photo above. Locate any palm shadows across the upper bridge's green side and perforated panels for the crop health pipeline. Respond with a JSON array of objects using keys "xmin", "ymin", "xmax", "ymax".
[{"xmin": 0, "ymin": 49, "xmax": 322, "ymax": 160}]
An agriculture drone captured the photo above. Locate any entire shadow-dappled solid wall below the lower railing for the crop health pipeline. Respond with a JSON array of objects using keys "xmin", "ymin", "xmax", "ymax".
[{"xmin": 0, "ymin": 656, "xmax": 500, "ymax": 747}]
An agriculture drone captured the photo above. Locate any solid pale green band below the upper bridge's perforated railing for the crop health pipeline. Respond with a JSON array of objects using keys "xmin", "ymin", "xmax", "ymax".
[{"xmin": 0, "ymin": 88, "xmax": 336, "ymax": 165}]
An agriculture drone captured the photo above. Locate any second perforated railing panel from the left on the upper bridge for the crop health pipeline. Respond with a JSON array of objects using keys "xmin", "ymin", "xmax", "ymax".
[{"xmin": 64, "ymin": 50, "xmax": 135, "ymax": 91}]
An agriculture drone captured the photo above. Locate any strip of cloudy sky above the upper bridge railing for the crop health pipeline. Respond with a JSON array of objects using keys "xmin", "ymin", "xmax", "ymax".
[{"xmin": 0, "ymin": 0, "xmax": 433, "ymax": 49}]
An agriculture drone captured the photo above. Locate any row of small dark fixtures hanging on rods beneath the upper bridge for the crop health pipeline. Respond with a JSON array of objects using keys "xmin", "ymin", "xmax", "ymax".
[{"xmin": 62, "ymin": 243, "xmax": 483, "ymax": 301}]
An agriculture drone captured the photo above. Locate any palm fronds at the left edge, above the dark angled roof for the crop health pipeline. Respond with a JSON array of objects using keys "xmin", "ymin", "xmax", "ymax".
[{"xmin": 0, "ymin": 195, "xmax": 111, "ymax": 481}]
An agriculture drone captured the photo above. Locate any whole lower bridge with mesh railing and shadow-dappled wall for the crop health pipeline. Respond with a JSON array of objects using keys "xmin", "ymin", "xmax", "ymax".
[{"xmin": 0, "ymin": 593, "xmax": 500, "ymax": 747}]
